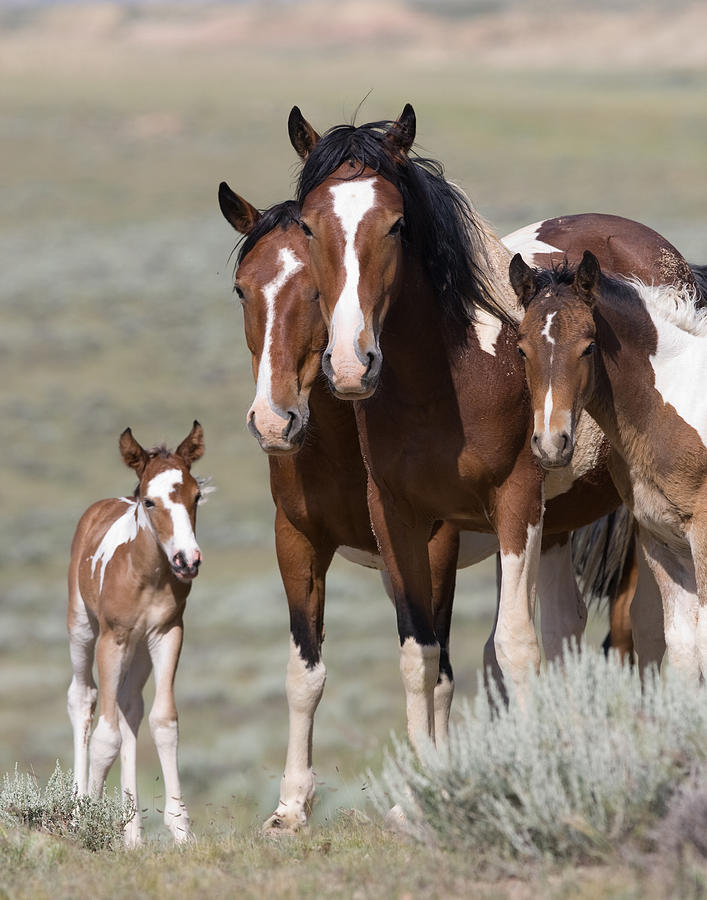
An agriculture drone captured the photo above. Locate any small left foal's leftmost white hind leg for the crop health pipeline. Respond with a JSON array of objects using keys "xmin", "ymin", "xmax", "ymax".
[{"xmin": 66, "ymin": 587, "xmax": 98, "ymax": 795}]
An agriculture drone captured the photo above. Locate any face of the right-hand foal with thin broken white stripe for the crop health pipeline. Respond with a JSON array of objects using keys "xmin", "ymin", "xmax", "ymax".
[{"xmin": 514, "ymin": 253, "xmax": 596, "ymax": 468}]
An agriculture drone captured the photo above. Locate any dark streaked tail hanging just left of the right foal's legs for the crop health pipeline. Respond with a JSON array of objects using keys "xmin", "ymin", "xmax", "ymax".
[{"xmin": 572, "ymin": 506, "xmax": 634, "ymax": 606}]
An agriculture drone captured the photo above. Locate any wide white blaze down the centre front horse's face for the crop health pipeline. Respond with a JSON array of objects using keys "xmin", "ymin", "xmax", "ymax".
[{"xmin": 329, "ymin": 178, "xmax": 376, "ymax": 371}]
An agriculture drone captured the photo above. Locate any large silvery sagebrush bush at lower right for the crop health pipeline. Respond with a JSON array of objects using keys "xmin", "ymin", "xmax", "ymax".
[{"xmin": 369, "ymin": 648, "xmax": 707, "ymax": 859}]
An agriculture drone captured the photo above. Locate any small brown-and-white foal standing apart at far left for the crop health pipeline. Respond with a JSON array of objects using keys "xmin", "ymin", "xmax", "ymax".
[{"xmin": 67, "ymin": 421, "xmax": 208, "ymax": 846}]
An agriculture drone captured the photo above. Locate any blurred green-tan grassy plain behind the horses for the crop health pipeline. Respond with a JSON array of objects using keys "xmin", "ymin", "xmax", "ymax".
[{"xmin": 0, "ymin": 3, "xmax": 707, "ymax": 896}]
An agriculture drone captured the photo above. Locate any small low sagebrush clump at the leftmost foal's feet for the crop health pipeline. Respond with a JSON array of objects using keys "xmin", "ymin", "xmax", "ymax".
[{"xmin": 0, "ymin": 762, "xmax": 136, "ymax": 850}]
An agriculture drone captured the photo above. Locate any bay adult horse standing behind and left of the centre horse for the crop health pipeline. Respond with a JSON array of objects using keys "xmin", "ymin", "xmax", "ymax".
[{"xmin": 219, "ymin": 182, "xmax": 632, "ymax": 833}]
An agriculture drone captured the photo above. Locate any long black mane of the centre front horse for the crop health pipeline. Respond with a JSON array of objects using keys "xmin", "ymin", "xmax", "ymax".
[{"xmin": 297, "ymin": 121, "xmax": 511, "ymax": 326}]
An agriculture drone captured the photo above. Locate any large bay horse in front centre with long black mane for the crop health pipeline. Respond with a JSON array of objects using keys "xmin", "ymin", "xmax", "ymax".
[{"xmin": 290, "ymin": 105, "xmax": 696, "ymax": 741}]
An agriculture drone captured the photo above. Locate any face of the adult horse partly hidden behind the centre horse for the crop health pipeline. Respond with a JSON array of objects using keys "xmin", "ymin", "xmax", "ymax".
[{"xmin": 236, "ymin": 225, "xmax": 326, "ymax": 455}]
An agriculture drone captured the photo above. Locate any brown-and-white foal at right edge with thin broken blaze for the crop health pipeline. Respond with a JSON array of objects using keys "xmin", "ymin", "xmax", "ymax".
[{"xmin": 510, "ymin": 252, "xmax": 707, "ymax": 680}]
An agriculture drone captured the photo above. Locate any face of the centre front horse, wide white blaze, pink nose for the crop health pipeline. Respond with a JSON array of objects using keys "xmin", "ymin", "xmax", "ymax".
[{"xmin": 301, "ymin": 163, "xmax": 403, "ymax": 400}]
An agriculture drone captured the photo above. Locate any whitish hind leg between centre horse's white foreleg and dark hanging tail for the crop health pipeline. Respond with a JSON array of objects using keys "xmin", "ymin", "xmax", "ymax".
[{"xmin": 538, "ymin": 533, "xmax": 587, "ymax": 660}]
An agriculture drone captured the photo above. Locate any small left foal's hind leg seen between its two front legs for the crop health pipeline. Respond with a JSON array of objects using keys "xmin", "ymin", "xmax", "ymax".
[{"xmin": 118, "ymin": 643, "xmax": 152, "ymax": 847}]
